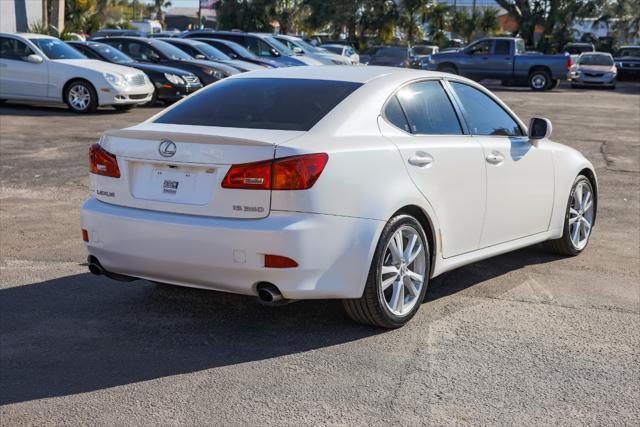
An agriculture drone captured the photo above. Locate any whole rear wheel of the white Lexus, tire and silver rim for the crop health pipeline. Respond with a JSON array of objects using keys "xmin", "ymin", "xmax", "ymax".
[{"xmin": 343, "ymin": 215, "xmax": 430, "ymax": 329}]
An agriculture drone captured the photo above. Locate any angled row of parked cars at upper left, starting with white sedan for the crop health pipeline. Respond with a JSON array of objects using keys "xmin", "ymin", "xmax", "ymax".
[{"xmin": 0, "ymin": 31, "xmax": 359, "ymax": 113}]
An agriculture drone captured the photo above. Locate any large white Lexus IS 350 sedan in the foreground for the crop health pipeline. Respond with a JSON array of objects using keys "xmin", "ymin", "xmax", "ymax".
[{"xmin": 82, "ymin": 66, "xmax": 597, "ymax": 328}]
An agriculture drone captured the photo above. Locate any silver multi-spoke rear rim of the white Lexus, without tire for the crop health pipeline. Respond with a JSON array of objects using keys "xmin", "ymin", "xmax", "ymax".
[{"xmin": 379, "ymin": 225, "xmax": 426, "ymax": 316}]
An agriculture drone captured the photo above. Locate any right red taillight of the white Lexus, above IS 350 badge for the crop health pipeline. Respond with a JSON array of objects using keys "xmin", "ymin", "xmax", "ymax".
[{"xmin": 222, "ymin": 153, "xmax": 329, "ymax": 190}]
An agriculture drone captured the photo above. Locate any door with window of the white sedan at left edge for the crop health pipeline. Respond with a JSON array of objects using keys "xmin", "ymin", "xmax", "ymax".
[{"xmin": 0, "ymin": 36, "xmax": 49, "ymax": 99}]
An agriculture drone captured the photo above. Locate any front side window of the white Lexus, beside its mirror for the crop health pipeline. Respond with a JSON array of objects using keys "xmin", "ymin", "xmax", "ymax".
[{"xmin": 451, "ymin": 82, "xmax": 522, "ymax": 136}]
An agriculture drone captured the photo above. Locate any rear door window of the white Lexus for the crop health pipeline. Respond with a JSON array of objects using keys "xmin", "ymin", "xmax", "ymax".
[{"xmin": 397, "ymin": 80, "xmax": 462, "ymax": 135}]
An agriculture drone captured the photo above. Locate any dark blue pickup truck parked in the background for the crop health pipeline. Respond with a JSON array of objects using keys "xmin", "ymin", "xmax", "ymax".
[{"xmin": 426, "ymin": 37, "xmax": 572, "ymax": 90}]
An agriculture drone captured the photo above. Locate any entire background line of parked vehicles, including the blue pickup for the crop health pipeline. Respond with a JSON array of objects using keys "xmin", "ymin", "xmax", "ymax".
[{"xmin": 0, "ymin": 31, "xmax": 640, "ymax": 113}]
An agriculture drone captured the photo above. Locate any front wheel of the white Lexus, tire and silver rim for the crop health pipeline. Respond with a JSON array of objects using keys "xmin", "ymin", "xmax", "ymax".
[{"xmin": 544, "ymin": 175, "xmax": 598, "ymax": 256}]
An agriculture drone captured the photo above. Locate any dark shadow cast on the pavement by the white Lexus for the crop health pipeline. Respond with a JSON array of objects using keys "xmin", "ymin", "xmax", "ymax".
[{"xmin": 0, "ymin": 247, "xmax": 558, "ymax": 405}]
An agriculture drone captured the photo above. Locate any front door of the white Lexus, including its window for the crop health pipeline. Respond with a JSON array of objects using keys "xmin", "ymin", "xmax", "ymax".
[{"xmin": 450, "ymin": 81, "xmax": 554, "ymax": 248}]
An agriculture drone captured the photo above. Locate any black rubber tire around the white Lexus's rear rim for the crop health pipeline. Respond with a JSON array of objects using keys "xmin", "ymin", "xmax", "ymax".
[{"xmin": 342, "ymin": 215, "xmax": 431, "ymax": 329}]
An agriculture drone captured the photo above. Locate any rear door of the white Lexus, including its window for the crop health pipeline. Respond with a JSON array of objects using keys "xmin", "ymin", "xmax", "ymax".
[{"xmin": 380, "ymin": 80, "xmax": 486, "ymax": 258}]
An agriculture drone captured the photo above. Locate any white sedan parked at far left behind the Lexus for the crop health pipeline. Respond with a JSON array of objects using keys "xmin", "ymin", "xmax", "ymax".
[{"xmin": 0, "ymin": 33, "xmax": 154, "ymax": 113}]
